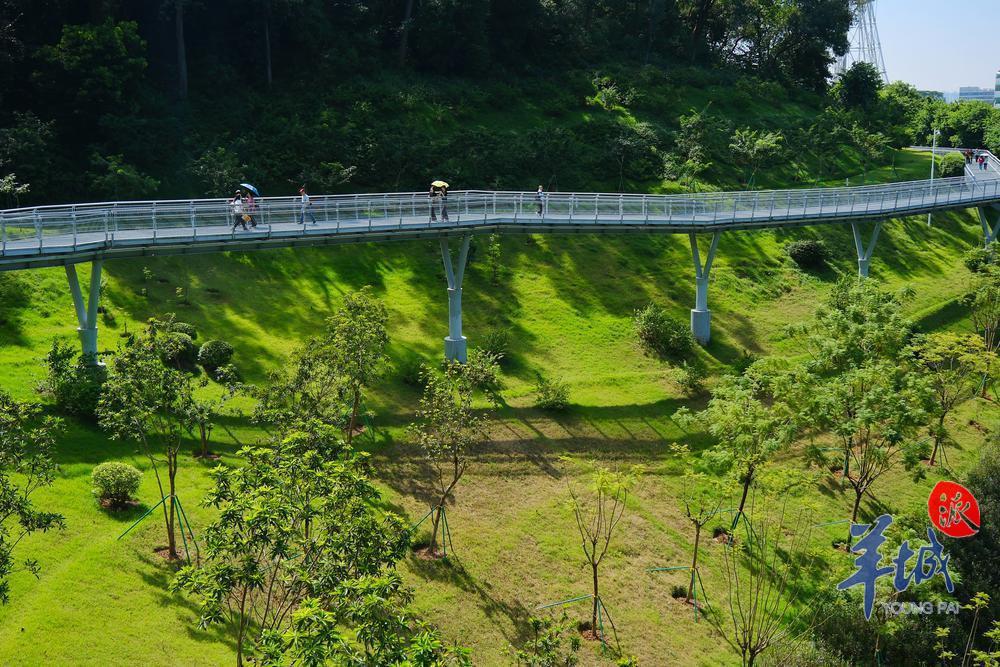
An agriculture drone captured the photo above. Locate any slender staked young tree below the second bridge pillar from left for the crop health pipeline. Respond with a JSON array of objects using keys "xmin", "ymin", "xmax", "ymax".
[{"xmin": 410, "ymin": 352, "xmax": 500, "ymax": 555}]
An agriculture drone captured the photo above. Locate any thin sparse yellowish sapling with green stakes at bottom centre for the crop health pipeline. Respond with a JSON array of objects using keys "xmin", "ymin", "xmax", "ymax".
[{"xmin": 569, "ymin": 463, "xmax": 642, "ymax": 644}]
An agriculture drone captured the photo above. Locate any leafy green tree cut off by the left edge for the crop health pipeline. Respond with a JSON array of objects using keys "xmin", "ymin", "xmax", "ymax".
[{"xmin": 0, "ymin": 391, "xmax": 66, "ymax": 604}]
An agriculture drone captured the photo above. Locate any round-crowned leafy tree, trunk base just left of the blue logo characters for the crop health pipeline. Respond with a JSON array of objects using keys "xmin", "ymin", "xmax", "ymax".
[{"xmin": 810, "ymin": 362, "xmax": 932, "ymax": 544}]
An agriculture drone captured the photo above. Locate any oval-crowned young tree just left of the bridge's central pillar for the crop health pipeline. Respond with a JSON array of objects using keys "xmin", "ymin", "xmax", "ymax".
[{"xmin": 328, "ymin": 287, "xmax": 389, "ymax": 445}]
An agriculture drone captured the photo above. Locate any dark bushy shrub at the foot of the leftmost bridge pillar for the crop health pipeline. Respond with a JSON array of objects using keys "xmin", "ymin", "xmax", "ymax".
[{"xmin": 39, "ymin": 341, "xmax": 108, "ymax": 419}]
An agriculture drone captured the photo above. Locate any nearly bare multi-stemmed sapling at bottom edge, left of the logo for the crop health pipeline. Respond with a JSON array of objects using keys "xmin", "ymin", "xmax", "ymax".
[{"xmin": 710, "ymin": 501, "xmax": 813, "ymax": 667}]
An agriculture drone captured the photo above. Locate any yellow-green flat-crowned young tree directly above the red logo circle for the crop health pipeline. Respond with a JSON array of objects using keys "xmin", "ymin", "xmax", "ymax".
[{"xmin": 908, "ymin": 331, "xmax": 996, "ymax": 466}]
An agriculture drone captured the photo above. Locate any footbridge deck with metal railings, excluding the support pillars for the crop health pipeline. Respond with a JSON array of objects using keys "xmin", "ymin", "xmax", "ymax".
[{"xmin": 0, "ymin": 149, "xmax": 1000, "ymax": 259}]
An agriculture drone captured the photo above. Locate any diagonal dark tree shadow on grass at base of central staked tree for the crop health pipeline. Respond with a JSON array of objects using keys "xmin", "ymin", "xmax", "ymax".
[{"xmin": 408, "ymin": 554, "xmax": 531, "ymax": 646}]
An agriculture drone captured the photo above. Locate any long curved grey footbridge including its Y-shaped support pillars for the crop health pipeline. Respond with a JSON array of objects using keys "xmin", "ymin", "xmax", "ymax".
[{"xmin": 0, "ymin": 149, "xmax": 1000, "ymax": 361}]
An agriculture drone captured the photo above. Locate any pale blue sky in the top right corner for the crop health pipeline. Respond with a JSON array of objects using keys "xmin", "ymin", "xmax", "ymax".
[{"xmin": 875, "ymin": 0, "xmax": 1000, "ymax": 92}]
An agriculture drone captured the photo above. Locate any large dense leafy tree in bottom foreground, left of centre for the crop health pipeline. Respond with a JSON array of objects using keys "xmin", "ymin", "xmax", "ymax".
[{"xmin": 172, "ymin": 429, "xmax": 454, "ymax": 665}]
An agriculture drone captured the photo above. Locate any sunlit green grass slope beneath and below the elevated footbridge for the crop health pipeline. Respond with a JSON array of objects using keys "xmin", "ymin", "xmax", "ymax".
[{"xmin": 0, "ymin": 146, "xmax": 996, "ymax": 665}]
